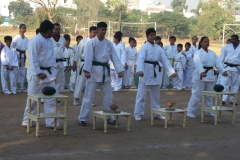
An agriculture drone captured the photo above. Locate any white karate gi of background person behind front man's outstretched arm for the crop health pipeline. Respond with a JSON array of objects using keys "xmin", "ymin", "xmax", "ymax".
[{"xmin": 109, "ymin": 42, "xmax": 126, "ymax": 91}]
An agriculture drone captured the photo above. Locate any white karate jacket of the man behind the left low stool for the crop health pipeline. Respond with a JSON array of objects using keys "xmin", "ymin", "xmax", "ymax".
[{"xmin": 83, "ymin": 36, "xmax": 124, "ymax": 82}]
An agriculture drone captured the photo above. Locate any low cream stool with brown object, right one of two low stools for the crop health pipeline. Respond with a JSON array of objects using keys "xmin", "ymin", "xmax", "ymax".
[{"xmin": 151, "ymin": 108, "xmax": 187, "ymax": 128}]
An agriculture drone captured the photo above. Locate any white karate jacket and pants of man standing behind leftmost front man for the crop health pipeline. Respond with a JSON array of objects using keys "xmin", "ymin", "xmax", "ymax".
[{"xmin": 51, "ymin": 36, "xmax": 66, "ymax": 93}]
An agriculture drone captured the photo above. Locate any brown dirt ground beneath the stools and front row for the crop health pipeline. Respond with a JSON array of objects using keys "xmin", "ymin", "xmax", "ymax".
[{"xmin": 0, "ymin": 91, "xmax": 240, "ymax": 160}]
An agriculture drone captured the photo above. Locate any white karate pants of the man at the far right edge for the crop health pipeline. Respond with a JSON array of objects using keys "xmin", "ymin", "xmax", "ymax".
[{"xmin": 221, "ymin": 71, "xmax": 239, "ymax": 102}]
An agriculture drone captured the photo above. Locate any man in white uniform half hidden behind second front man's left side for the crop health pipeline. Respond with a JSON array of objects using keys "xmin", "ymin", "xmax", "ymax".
[{"xmin": 73, "ymin": 26, "xmax": 97, "ymax": 106}]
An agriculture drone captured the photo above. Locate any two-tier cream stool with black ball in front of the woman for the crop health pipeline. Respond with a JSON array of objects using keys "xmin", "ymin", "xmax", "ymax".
[{"xmin": 201, "ymin": 91, "xmax": 237, "ymax": 125}]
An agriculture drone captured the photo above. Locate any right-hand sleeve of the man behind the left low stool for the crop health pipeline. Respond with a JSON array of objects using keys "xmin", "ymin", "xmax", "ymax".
[{"xmin": 109, "ymin": 43, "xmax": 125, "ymax": 73}]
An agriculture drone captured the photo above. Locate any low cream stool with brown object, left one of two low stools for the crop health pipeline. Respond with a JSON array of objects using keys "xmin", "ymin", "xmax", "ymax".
[{"xmin": 93, "ymin": 111, "xmax": 132, "ymax": 133}]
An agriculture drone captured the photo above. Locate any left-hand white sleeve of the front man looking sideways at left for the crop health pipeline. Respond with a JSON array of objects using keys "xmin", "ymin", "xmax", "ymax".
[{"xmin": 28, "ymin": 39, "xmax": 42, "ymax": 74}]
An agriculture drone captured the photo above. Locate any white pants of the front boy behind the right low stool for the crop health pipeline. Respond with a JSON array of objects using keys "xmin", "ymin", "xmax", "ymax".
[{"xmin": 134, "ymin": 82, "xmax": 160, "ymax": 117}]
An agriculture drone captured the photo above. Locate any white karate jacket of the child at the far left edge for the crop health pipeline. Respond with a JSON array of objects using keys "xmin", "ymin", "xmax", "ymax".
[{"xmin": 1, "ymin": 46, "xmax": 18, "ymax": 70}]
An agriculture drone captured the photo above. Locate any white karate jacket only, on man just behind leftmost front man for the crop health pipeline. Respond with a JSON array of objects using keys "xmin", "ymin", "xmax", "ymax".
[{"xmin": 51, "ymin": 36, "xmax": 66, "ymax": 68}]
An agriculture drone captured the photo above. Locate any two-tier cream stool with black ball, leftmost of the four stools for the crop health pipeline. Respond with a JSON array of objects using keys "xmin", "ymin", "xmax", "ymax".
[{"xmin": 27, "ymin": 94, "xmax": 68, "ymax": 137}]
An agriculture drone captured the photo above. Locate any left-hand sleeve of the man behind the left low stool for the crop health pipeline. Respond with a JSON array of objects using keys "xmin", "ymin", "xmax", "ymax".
[{"xmin": 83, "ymin": 41, "xmax": 93, "ymax": 72}]
